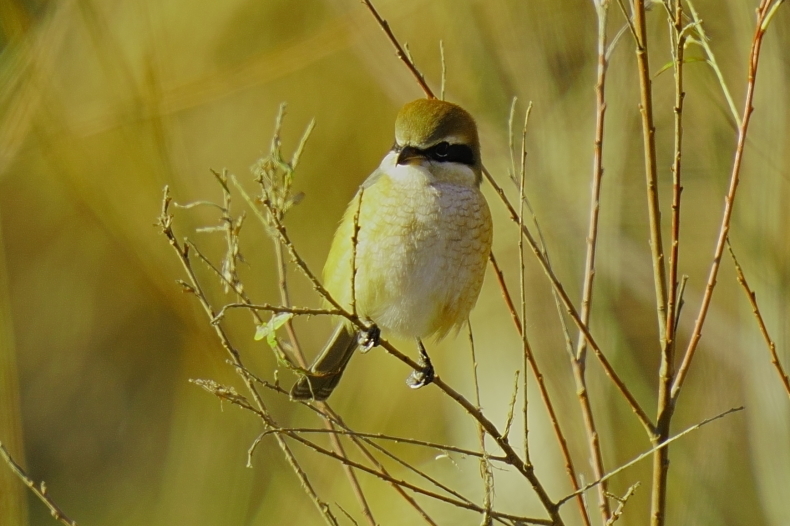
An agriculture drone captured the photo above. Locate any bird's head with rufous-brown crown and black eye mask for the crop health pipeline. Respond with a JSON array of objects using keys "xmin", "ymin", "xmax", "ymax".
[{"xmin": 393, "ymin": 99, "xmax": 482, "ymax": 185}]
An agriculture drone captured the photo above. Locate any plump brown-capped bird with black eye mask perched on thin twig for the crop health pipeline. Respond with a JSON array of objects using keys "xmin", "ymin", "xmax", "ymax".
[{"xmin": 291, "ymin": 99, "xmax": 492, "ymax": 400}]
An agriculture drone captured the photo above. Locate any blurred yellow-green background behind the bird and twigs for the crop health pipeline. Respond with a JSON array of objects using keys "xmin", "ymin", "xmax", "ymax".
[{"xmin": 0, "ymin": 0, "xmax": 790, "ymax": 526}]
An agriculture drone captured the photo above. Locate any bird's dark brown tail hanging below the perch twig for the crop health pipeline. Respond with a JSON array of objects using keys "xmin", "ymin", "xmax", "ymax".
[{"xmin": 291, "ymin": 323, "xmax": 359, "ymax": 400}]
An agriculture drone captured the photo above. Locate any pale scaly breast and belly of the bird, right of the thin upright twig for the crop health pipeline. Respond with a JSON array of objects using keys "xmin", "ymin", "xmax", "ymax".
[{"xmin": 356, "ymin": 185, "xmax": 491, "ymax": 338}]
